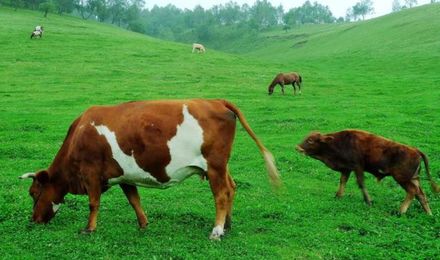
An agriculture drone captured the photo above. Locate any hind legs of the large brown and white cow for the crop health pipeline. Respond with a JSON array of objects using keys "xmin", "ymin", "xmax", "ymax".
[{"xmin": 208, "ymin": 169, "xmax": 234, "ymax": 240}]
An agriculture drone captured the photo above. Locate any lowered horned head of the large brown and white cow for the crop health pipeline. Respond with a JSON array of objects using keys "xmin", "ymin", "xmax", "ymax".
[{"xmin": 20, "ymin": 170, "xmax": 64, "ymax": 223}]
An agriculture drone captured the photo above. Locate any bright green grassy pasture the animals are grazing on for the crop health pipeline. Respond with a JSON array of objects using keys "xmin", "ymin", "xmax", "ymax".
[{"xmin": 0, "ymin": 4, "xmax": 440, "ymax": 259}]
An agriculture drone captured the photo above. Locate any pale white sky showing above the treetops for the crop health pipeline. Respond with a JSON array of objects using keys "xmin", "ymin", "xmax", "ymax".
[{"xmin": 145, "ymin": 0, "xmax": 430, "ymax": 17}]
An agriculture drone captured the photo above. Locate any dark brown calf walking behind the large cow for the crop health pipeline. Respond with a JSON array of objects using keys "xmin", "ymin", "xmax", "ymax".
[{"xmin": 297, "ymin": 130, "xmax": 440, "ymax": 215}]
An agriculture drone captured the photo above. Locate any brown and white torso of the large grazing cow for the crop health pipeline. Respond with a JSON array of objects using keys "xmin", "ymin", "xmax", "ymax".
[{"xmin": 62, "ymin": 100, "xmax": 235, "ymax": 189}]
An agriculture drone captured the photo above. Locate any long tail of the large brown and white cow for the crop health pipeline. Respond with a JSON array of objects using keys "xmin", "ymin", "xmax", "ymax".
[{"xmin": 223, "ymin": 100, "xmax": 281, "ymax": 188}]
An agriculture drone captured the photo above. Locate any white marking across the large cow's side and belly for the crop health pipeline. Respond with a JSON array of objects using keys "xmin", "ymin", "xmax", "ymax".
[{"xmin": 91, "ymin": 105, "xmax": 207, "ymax": 188}]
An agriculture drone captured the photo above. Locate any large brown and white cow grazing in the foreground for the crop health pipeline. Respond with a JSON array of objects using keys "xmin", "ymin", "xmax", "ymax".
[{"xmin": 21, "ymin": 99, "xmax": 279, "ymax": 239}]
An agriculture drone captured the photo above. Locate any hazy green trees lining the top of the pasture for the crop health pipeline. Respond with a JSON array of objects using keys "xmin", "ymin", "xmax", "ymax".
[{"xmin": 0, "ymin": 0, "xmax": 435, "ymax": 45}]
